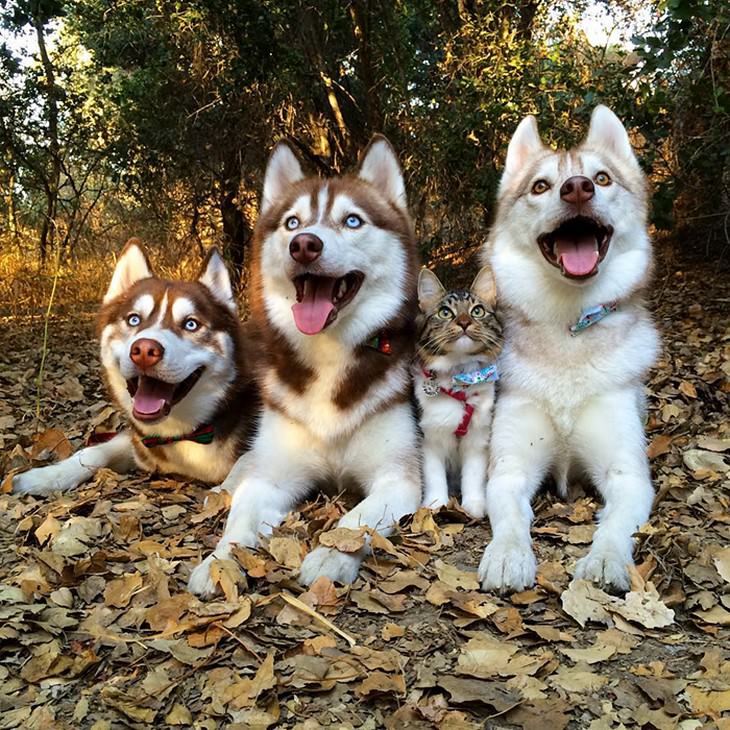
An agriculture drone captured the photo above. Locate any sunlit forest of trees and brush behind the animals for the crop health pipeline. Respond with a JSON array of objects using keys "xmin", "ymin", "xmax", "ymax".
[{"xmin": 0, "ymin": 0, "xmax": 730, "ymax": 314}]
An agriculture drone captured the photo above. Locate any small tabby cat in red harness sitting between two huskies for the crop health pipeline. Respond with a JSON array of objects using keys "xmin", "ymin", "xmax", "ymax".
[{"xmin": 413, "ymin": 266, "xmax": 502, "ymax": 518}]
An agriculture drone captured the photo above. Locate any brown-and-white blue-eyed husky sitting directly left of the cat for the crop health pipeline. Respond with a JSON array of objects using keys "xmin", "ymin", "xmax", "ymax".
[{"xmin": 189, "ymin": 136, "xmax": 420, "ymax": 594}]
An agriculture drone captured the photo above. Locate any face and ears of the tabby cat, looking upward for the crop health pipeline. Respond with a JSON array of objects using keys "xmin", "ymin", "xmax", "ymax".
[{"xmin": 418, "ymin": 267, "xmax": 502, "ymax": 359}]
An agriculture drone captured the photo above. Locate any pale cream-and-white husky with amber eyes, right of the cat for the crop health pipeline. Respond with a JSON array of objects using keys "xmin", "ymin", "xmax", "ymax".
[{"xmin": 479, "ymin": 106, "xmax": 659, "ymax": 591}]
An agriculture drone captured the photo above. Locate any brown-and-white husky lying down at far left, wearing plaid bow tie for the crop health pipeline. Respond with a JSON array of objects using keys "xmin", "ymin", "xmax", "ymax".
[{"xmin": 13, "ymin": 238, "xmax": 260, "ymax": 495}]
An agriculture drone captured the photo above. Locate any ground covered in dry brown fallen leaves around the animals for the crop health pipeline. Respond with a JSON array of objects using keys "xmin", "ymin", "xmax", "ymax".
[{"xmin": 0, "ymin": 252, "xmax": 730, "ymax": 730}]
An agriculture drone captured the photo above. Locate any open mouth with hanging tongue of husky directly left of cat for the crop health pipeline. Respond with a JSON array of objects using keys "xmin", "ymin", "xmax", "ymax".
[{"xmin": 292, "ymin": 271, "xmax": 365, "ymax": 335}]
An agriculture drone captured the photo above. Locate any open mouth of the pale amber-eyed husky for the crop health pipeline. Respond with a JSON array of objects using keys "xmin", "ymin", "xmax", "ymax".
[{"xmin": 537, "ymin": 216, "xmax": 613, "ymax": 279}]
